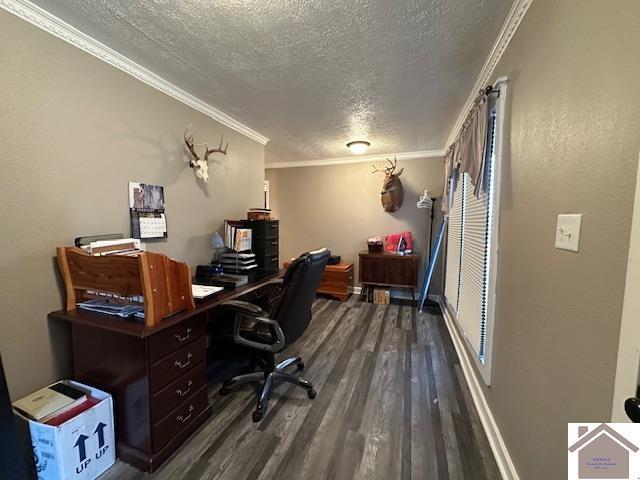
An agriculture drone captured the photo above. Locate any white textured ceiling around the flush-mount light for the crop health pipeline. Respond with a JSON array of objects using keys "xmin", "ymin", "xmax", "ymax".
[{"xmin": 30, "ymin": 0, "xmax": 512, "ymax": 162}]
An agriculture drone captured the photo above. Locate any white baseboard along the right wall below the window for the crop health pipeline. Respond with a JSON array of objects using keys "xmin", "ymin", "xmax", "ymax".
[{"xmin": 437, "ymin": 296, "xmax": 520, "ymax": 480}]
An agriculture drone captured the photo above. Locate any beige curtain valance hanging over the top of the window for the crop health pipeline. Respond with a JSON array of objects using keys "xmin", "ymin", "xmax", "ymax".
[{"xmin": 441, "ymin": 92, "xmax": 489, "ymax": 213}]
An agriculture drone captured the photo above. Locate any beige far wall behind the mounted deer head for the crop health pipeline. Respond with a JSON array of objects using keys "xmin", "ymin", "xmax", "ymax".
[{"xmin": 266, "ymin": 158, "xmax": 444, "ymax": 294}]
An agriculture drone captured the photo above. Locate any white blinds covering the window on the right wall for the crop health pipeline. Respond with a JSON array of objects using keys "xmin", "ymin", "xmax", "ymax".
[{"xmin": 445, "ymin": 110, "xmax": 495, "ymax": 360}]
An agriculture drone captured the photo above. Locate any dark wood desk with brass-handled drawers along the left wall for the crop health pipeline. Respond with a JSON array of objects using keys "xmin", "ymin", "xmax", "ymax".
[{"xmin": 49, "ymin": 271, "xmax": 281, "ymax": 472}]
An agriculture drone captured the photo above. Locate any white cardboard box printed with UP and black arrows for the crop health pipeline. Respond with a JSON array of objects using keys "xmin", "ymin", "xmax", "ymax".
[{"xmin": 14, "ymin": 381, "xmax": 116, "ymax": 480}]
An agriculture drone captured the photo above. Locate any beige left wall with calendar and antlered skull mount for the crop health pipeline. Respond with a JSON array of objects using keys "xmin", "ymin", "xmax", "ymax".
[{"xmin": 0, "ymin": 11, "xmax": 264, "ymax": 398}]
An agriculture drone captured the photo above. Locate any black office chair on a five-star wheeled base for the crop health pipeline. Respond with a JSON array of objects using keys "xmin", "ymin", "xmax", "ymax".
[{"xmin": 220, "ymin": 248, "xmax": 331, "ymax": 422}]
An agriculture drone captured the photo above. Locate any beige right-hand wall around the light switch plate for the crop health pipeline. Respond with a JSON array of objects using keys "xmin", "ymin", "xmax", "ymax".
[{"xmin": 464, "ymin": 0, "xmax": 640, "ymax": 480}]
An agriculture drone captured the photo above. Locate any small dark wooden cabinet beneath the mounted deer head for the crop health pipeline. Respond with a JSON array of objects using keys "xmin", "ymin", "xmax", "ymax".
[{"xmin": 359, "ymin": 252, "xmax": 420, "ymax": 297}]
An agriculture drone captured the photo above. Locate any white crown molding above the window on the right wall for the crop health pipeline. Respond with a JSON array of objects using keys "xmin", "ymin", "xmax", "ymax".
[{"xmin": 444, "ymin": 0, "xmax": 533, "ymax": 151}]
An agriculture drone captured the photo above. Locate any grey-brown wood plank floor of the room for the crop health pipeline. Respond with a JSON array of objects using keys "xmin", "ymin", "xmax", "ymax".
[{"xmin": 100, "ymin": 296, "xmax": 500, "ymax": 480}]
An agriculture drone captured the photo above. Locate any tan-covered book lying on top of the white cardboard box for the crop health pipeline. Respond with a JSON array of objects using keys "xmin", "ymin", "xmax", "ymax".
[{"xmin": 12, "ymin": 382, "xmax": 87, "ymax": 422}]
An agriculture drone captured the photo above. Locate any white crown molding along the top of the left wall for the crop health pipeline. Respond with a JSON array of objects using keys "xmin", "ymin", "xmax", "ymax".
[{"xmin": 0, "ymin": 0, "xmax": 269, "ymax": 145}]
